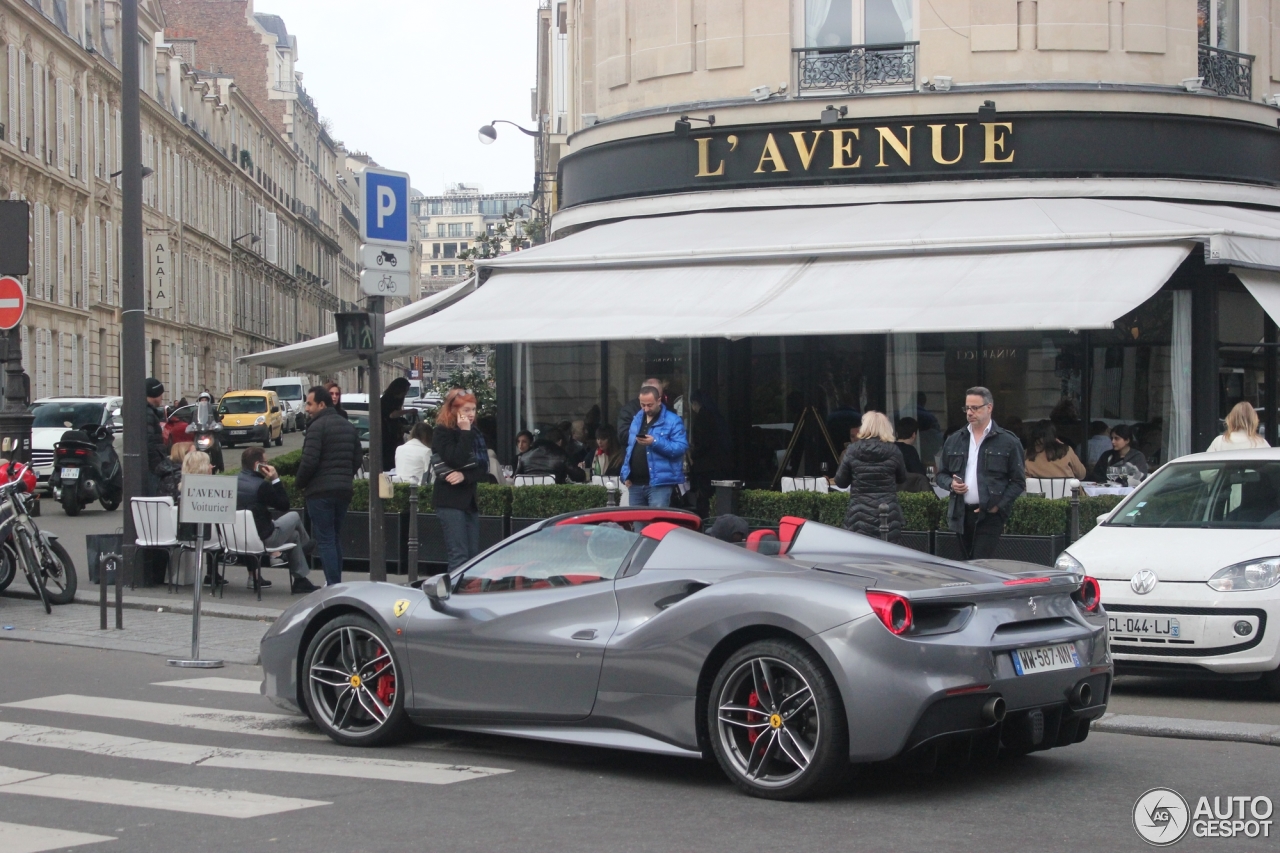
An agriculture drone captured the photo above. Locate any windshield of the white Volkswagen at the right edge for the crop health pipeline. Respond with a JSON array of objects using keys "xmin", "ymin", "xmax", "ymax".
[{"xmin": 1107, "ymin": 460, "xmax": 1280, "ymax": 530}]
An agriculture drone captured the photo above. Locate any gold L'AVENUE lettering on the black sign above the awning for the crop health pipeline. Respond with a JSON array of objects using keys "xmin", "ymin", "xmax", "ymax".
[{"xmin": 694, "ymin": 122, "xmax": 1014, "ymax": 178}]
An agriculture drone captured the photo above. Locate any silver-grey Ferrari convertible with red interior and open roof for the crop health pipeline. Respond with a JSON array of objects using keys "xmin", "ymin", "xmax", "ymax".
[{"xmin": 261, "ymin": 508, "xmax": 1112, "ymax": 799}]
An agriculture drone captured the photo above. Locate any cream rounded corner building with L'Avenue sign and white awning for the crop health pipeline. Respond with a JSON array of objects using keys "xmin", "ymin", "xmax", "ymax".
[{"xmin": 417, "ymin": 0, "xmax": 1280, "ymax": 484}]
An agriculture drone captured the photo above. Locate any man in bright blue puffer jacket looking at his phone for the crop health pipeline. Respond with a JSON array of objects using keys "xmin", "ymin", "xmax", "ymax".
[{"xmin": 622, "ymin": 386, "xmax": 689, "ymax": 506}]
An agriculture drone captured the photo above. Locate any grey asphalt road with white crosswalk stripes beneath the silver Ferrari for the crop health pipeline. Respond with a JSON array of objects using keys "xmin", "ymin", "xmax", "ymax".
[{"xmin": 0, "ymin": 643, "xmax": 1280, "ymax": 853}]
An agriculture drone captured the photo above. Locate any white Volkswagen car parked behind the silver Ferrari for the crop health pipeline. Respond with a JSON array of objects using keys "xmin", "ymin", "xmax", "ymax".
[{"xmin": 1057, "ymin": 450, "xmax": 1280, "ymax": 698}]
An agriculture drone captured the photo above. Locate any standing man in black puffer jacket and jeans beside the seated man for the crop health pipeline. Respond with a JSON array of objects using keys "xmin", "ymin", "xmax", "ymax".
[{"xmin": 294, "ymin": 386, "xmax": 365, "ymax": 585}]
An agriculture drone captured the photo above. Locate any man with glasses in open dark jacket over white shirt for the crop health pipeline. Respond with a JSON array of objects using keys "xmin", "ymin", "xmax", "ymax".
[{"xmin": 936, "ymin": 386, "xmax": 1027, "ymax": 560}]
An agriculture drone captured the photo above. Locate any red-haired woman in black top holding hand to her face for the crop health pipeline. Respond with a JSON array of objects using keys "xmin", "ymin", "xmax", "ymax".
[{"xmin": 431, "ymin": 388, "xmax": 481, "ymax": 563}]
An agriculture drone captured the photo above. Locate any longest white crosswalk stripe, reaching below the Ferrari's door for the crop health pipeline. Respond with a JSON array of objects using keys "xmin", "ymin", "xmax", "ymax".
[{"xmin": 0, "ymin": 722, "xmax": 511, "ymax": 790}]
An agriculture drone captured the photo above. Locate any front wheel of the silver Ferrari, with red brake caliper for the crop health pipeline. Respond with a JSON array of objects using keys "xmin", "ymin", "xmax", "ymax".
[{"xmin": 303, "ymin": 615, "xmax": 404, "ymax": 747}]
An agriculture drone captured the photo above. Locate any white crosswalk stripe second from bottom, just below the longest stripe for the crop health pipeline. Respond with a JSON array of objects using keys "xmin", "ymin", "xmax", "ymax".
[{"xmin": 0, "ymin": 767, "xmax": 333, "ymax": 818}]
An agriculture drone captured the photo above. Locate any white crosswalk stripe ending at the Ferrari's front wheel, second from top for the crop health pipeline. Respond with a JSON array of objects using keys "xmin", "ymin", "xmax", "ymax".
[{"xmin": 0, "ymin": 693, "xmax": 325, "ymax": 740}]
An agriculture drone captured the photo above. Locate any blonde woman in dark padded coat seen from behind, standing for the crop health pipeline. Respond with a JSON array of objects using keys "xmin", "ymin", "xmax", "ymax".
[{"xmin": 836, "ymin": 411, "xmax": 906, "ymax": 542}]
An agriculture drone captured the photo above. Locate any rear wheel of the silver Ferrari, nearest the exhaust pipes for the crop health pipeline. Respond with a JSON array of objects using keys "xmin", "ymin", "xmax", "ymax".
[{"xmin": 707, "ymin": 640, "xmax": 849, "ymax": 799}]
